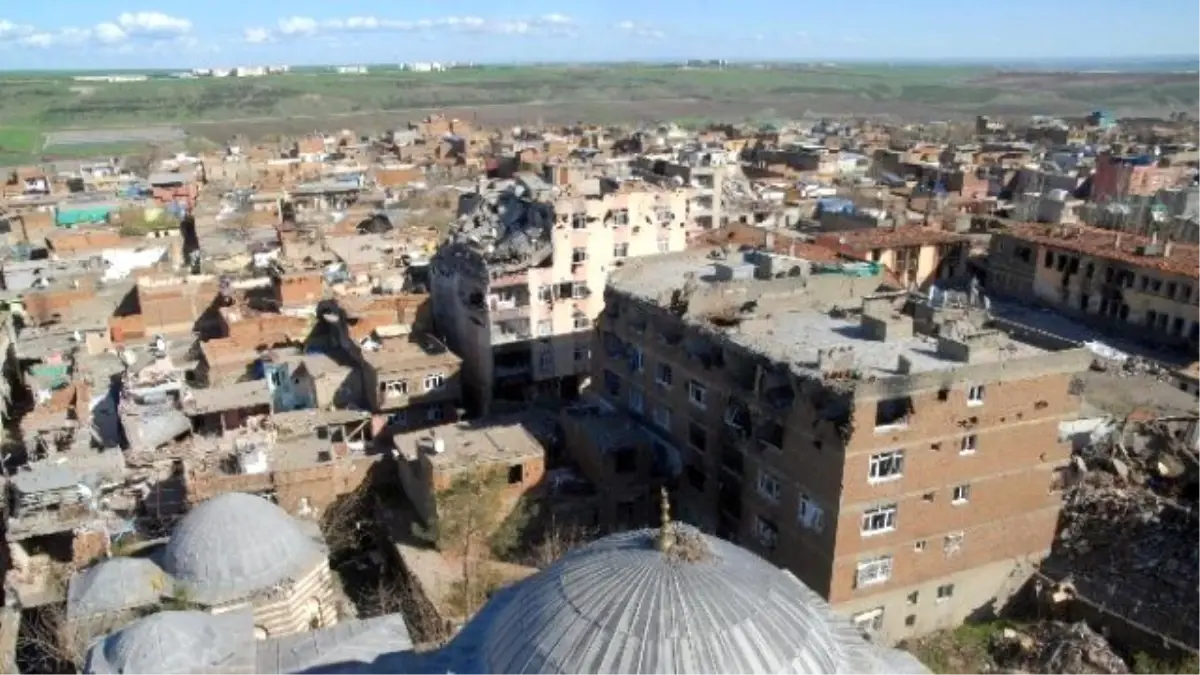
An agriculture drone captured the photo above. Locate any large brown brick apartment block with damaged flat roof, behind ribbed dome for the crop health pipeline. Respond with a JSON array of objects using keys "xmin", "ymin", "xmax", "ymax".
[{"xmin": 593, "ymin": 243, "xmax": 1090, "ymax": 641}]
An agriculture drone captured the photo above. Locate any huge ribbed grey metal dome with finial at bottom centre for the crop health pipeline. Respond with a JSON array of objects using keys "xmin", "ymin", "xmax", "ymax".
[{"xmin": 478, "ymin": 525, "xmax": 877, "ymax": 675}]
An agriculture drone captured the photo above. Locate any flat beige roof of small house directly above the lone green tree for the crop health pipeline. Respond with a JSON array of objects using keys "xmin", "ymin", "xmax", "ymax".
[{"xmin": 392, "ymin": 418, "xmax": 545, "ymax": 472}]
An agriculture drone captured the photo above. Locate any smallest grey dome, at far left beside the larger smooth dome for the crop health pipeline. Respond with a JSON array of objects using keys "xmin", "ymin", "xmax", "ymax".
[{"xmin": 67, "ymin": 557, "xmax": 170, "ymax": 619}]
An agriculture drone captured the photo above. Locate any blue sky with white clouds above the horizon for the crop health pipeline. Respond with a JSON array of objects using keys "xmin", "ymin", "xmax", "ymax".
[{"xmin": 0, "ymin": 0, "xmax": 1200, "ymax": 68}]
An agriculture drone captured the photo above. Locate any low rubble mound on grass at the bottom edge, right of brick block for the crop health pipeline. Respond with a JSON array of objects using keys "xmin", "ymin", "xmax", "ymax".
[{"xmin": 991, "ymin": 622, "xmax": 1132, "ymax": 675}]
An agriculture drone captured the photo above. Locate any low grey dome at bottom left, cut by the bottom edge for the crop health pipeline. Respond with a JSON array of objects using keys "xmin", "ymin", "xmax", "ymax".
[{"xmin": 85, "ymin": 611, "xmax": 253, "ymax": 675}]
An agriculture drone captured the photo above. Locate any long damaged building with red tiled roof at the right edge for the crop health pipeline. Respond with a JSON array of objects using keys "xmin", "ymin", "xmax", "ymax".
[{"xmin": 986, "ymin": 225, "xmax": 1200, "ymax": 347}]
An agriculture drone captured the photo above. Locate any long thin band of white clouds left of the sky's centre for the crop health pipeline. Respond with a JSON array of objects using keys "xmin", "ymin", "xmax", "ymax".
[{"xmin": 274, "ymin": 13, "xmax": 576, "ymax": 37}]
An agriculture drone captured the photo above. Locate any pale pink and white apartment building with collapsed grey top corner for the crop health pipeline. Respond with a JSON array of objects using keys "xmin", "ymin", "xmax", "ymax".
[{"xmin": 431, "ymin": 174, "xmax": 691, "ymax": 412}]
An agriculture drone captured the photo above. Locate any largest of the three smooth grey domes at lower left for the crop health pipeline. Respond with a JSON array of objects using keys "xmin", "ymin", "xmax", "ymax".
[{"xmin": 162, "ymin": 492, "xmax": 325, "ymax": 604}]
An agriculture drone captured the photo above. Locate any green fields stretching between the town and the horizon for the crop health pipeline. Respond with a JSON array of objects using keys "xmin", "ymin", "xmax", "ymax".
[{"xmin": 0, "ymin": 65, "xmax": 1200, "ymax": 163}]
